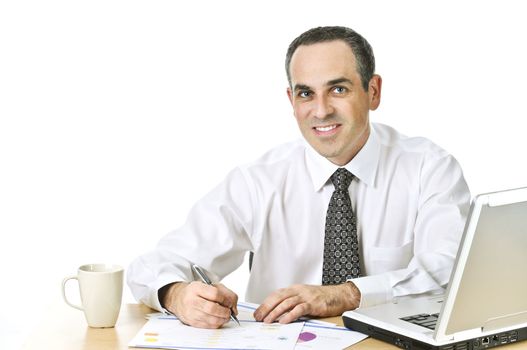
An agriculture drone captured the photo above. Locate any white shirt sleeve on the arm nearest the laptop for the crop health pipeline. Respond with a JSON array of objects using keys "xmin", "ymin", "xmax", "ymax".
[{"xmin": 352, "ymin": 154, "xmax": 470, "ymax": 308}]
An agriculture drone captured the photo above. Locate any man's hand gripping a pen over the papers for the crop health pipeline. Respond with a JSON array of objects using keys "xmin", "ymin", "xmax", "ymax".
[{"xmin": 159, "ymin": 282, "xmax": 238, "ymax": 328}]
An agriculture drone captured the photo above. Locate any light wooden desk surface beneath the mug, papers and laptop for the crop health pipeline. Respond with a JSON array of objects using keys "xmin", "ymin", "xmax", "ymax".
[{"xmin": 24, "ymin": 303, "xmax": 527, "ymax": 350}]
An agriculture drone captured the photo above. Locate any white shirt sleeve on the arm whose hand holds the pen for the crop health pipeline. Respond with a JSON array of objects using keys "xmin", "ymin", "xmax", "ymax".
[{"xmin": 127, "ymin": 169, "xmax": 253, "ymax": 311}]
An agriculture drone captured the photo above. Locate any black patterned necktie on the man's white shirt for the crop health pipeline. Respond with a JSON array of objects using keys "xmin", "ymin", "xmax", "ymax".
[{"xmin": 322, "ymin": 168, "xmax": 361, "ymax": 285}]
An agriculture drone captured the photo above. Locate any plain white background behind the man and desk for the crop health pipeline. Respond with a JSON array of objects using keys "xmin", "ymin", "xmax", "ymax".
[{"xmin": 0, "ymin": 0, "xmax": 527, "ymax": 348}]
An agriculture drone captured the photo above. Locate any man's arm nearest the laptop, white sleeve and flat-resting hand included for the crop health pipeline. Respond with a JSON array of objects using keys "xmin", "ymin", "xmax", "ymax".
[{"xmin": 255, "ymin": 155, "xmax": 470, "ymax": 322}]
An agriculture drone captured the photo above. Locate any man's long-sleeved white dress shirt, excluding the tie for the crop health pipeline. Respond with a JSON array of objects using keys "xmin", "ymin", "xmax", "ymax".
[{"xmin": 128, "ymin": 123, "xmax": 470, "ymax": 310}]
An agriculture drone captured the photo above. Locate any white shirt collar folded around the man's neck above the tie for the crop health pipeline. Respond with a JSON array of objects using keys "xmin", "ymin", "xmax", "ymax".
[{"xmin": 304, "ymin": 125, "xmax": 380, "ymax": 191}]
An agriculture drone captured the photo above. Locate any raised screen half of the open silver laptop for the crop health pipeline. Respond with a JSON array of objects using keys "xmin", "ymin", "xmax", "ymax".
[{"xmin": 444, "ymin": 189, "xmax": 527, "ymax": 334}]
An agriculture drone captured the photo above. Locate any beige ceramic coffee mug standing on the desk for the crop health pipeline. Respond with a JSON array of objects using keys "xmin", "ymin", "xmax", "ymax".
[{"xmin": 62, "ymin": 264, "xmax": 123, "ymax": 328}]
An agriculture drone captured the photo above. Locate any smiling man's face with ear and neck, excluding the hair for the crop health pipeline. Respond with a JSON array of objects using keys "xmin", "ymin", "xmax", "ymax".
[{"xmin": 287, "ymin": 40, "xmax": 381, "ymax": 165}]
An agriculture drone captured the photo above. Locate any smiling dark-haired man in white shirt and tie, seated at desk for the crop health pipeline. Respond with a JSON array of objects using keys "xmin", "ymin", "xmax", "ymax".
[{"xmin": 128, "ymin": 27, "xmax": 470, "ymax": 328}]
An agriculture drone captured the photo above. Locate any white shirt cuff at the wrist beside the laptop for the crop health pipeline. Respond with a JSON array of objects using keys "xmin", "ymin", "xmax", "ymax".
[{"xmin": 349, "ymin": 274, "xmax": 393, "ymax": 308}]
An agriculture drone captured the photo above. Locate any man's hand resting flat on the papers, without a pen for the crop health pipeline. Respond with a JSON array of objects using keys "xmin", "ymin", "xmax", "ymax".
[{"xmin": 254, "ymin": 282, "xmax": 360, "ymax": 323}]
